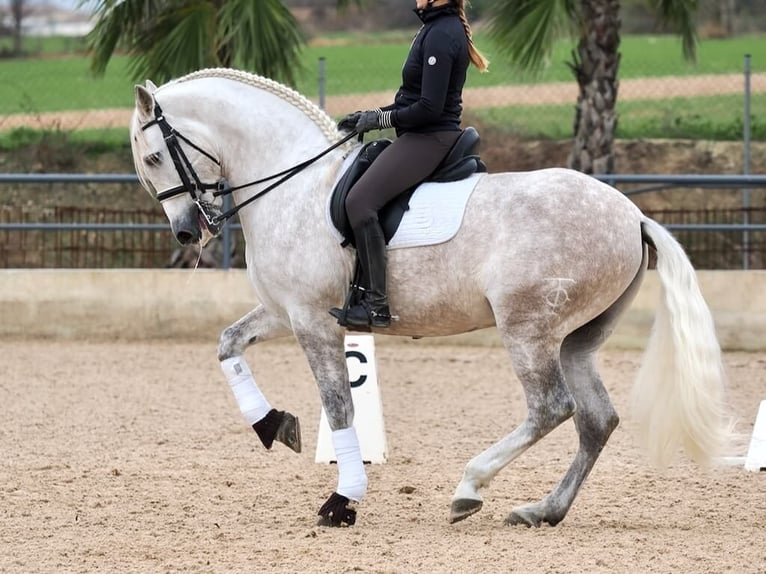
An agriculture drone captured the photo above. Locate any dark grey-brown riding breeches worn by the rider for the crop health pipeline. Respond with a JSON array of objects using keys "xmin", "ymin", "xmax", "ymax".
[{"xmin": 346, "ymin": 131, "xmax": 460, "ymax": 229}]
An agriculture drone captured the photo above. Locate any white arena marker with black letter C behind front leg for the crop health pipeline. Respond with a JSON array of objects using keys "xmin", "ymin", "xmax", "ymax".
[{"xmin": 314, "ymin": 335, "xmax": 388, "ymax": 463}]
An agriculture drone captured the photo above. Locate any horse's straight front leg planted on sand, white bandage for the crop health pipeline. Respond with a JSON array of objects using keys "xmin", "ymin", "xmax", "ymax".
[{"xmin": 293, "ymin": 317, "xmax": 367, "ymax": 526}]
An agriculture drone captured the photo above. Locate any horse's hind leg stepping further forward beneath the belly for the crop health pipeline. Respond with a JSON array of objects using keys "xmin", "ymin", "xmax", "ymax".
[{"xmin": 450, "ymin": 332, "xmax": 575, "ymax": 522}]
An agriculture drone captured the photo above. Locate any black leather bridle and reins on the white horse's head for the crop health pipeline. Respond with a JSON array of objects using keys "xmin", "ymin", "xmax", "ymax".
[{"xmin": 141, "ymin": 100, "xmax": 357, "ymax": 235}]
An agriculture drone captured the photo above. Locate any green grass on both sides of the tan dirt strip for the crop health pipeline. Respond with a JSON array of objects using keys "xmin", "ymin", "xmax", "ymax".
[{"xmin": 0, "ymin": 31, "xmax": 766, "ymax": 145}]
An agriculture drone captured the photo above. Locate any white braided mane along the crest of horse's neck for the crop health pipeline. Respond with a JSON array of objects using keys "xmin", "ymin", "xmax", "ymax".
[{"xmin": 165, "ymin": 68, "xmax": 340, "ymax": 141}]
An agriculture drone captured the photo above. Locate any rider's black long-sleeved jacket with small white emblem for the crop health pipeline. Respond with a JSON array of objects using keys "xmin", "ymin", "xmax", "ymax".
[{"xmin": 381, "ymin": 5, "xmax": 469, "ymax": 135}]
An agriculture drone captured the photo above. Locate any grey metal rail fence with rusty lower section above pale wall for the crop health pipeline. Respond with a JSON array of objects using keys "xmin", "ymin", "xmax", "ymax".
[{"xmin": 0, "ymin": 174, "xmax": 766, "ymax": 269}]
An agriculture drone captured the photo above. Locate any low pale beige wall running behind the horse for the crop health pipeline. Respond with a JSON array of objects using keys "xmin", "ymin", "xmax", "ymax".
[{"xmin": 0, "ymin": 269, "xmax": 766, "ymax": 351}]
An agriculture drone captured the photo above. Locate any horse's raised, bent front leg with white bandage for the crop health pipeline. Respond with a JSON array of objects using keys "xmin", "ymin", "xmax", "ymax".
[{"xmin": 218, "ymin": 305, "xmax": 301, "ymax": 452}]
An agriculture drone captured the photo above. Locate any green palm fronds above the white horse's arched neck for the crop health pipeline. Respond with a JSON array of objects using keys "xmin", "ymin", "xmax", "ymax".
[{"xmin": 80, "ymin": 0, "xmax": 363, "ymax": 85}]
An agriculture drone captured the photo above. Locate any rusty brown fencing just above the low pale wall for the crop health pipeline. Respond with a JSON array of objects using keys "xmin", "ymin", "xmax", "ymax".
[{"xmin": 0, "ymin": 206, "xmax": 766, "ymax": 269}]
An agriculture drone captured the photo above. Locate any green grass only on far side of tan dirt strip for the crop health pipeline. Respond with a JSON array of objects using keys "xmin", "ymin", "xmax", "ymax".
[{"xmin": 0, "ymin": 33, "xmax": 766, "ymax": 114}]
